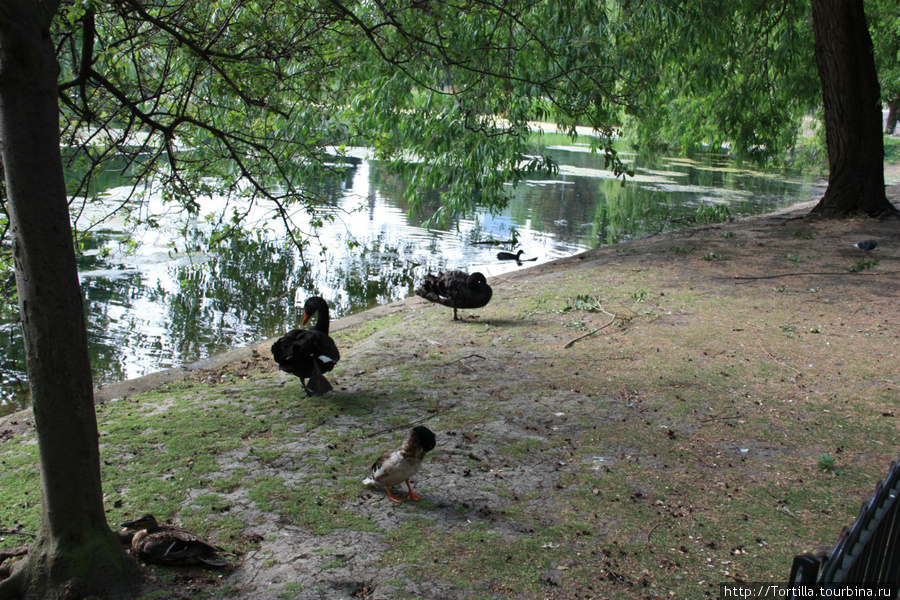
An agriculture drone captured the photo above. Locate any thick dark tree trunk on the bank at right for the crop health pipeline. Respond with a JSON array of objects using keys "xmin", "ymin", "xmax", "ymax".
[{"xmin": 812, "ymin": 0, "xmax": 897, "ymax": 218}]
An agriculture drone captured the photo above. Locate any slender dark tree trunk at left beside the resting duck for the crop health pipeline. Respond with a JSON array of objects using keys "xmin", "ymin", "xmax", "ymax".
[{"xmin": 0, "ymin": 0, "xmax": 138, "ymax": 600}]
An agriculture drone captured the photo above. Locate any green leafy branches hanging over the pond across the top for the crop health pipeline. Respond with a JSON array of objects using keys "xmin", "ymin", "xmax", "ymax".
[{"xmin": 1, "ymin": 0, "xmax": 900, "ymax": 247}]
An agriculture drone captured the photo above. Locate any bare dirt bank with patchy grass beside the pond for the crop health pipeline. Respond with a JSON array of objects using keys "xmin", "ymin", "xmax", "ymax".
[{"xmin": 0, "ymin": 179, "xmax": 900, "ymax": 600}]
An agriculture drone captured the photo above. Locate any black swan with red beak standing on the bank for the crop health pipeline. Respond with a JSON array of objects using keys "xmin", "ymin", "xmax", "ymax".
[{"xmin": 272, "ymin": 296, "xmax": 341, "ymax": 396}]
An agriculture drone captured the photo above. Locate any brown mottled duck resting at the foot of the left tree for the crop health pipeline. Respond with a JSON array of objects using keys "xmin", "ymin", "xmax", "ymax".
[{"xmin": 121, "ymin": 515, "xmax": 228, "ymax": 567}]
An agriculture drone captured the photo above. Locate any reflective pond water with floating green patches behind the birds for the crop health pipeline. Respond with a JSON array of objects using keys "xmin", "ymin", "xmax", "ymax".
[{"xmin": 0, "ymin": 134, "xmax": 822, "ymax": 415}]
